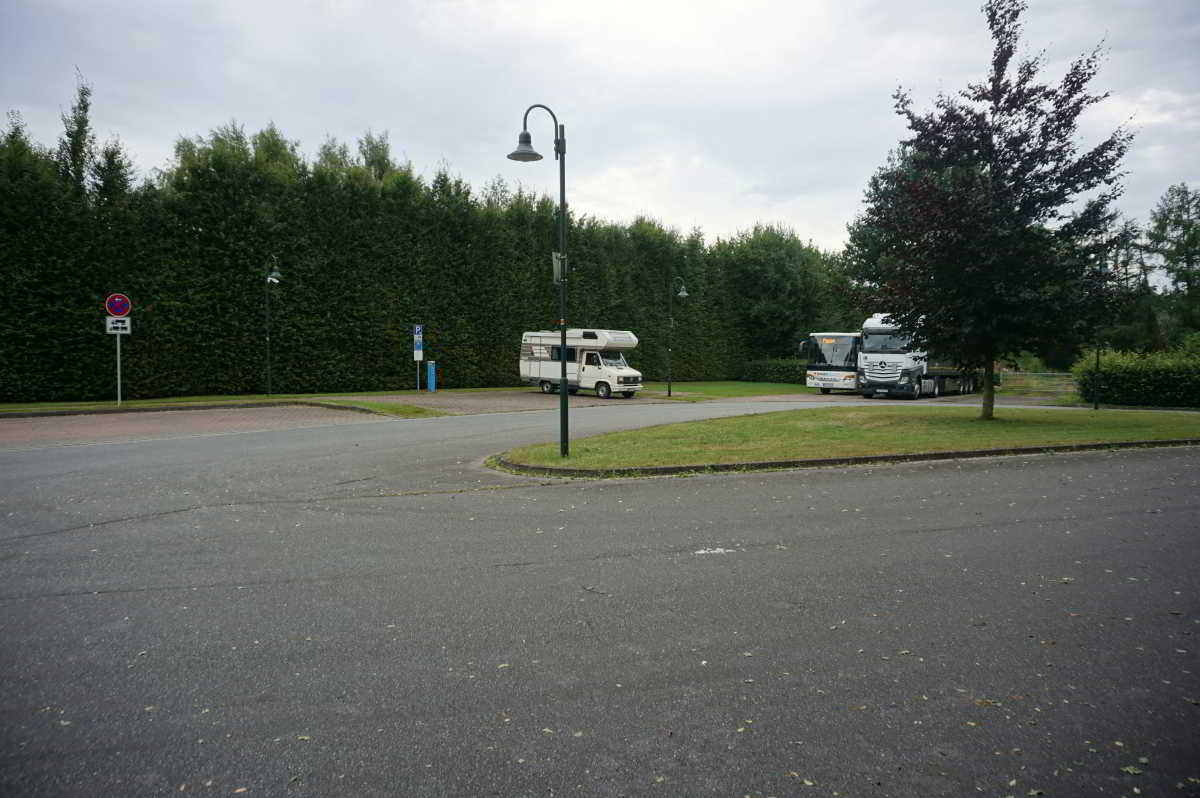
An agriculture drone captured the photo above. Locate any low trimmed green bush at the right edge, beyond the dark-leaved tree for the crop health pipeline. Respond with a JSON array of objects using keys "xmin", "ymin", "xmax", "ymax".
[{"xmin": 1070, "ymin": 348, "xmax": 1200, "ymax": 407}]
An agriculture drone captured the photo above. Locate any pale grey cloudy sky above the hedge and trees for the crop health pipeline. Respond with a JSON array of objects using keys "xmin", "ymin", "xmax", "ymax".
[{"xmin": 0, "ymin": 0, "xmax": 1200, "ymax": 248}]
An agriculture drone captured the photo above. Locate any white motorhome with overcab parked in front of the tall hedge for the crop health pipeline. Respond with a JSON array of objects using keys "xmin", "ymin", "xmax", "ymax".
[{"xmin": 521, "ymin": 330, "xmax": 642, "ymax": 398}]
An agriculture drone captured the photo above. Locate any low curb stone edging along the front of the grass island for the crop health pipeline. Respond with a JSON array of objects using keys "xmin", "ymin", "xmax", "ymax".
[{"xmin": 496, "ymin": 438, "xmax": 1200, "ymax": 479}]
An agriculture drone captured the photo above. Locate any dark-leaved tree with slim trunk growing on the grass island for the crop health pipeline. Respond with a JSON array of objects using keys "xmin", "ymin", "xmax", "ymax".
[{"xmin": 847, "ymin": 0, "xmax": 1132, "ymax": 419}]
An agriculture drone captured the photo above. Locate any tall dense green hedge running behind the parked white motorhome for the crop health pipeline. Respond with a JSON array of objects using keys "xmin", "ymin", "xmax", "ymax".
[{"xmin": 0, "ymin": 95, "xmax": 859, "ymax": 402}]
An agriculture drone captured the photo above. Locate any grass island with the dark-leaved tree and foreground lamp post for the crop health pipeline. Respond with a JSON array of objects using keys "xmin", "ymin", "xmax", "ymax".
[{"xmin": 508, "ymin": 407, "xmax": 1200, "ymax": 469}]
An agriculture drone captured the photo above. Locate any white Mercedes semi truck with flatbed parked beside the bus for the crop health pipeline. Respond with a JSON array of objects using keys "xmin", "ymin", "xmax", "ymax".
[{"xmin": 857, "ymin": 313, "xmax": 977, "ymax": 398}]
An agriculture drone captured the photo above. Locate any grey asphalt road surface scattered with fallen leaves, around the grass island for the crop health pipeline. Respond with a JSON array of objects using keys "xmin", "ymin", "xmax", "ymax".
[{"xmin": 0, "ymin": 402, "xmax": 1200, "ymax": 797}]
